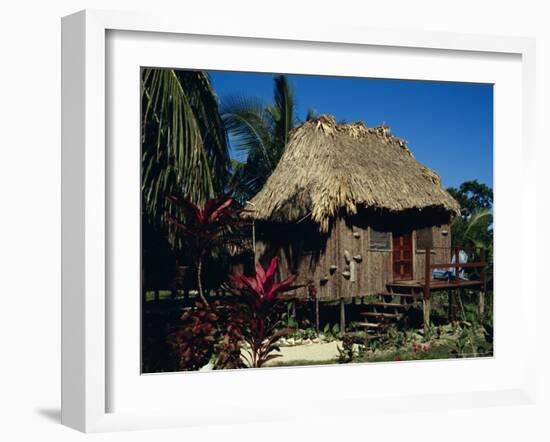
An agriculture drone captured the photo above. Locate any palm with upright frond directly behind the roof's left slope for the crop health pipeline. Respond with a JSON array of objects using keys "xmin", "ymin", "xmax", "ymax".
[{"xmin": 221, "ymin": 75, "xmax": 298, "ymax": 202}]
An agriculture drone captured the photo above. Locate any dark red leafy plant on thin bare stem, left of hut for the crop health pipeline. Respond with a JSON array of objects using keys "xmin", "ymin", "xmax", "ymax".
[{"xmin": 168, "ymin": 196, "xmax": 245, "ymax": 307}]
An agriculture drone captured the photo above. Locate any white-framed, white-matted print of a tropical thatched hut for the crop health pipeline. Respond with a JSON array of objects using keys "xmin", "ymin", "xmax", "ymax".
[{"xmin": 62, "ymin": 11, "xmax": 535, "ymax": 431}]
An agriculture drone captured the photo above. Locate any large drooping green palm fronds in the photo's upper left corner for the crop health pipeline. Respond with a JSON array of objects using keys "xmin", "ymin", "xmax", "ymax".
[{"xmin": 141, "ymin": 68, "xmax": 230, "ymax": 231}]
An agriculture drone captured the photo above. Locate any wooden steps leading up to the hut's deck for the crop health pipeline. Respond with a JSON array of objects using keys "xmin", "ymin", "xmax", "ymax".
[{"xmin": 357, "ymin": 285, "xmax": 423, "ymax": 340}]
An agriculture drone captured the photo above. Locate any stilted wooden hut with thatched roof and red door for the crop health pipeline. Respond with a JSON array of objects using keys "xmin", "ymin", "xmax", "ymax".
[{"xmin": 248, "ymin": 115, "xmax": 460, "ymax": 299}]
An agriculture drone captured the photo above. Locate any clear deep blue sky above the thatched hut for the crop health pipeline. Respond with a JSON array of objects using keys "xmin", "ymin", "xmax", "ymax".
[{"xmin": 209, "ymin": 72, "xmax": 493, "ymax": 187}]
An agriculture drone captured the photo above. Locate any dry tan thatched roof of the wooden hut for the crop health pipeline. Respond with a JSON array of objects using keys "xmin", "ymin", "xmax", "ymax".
[{"xmin": 248, "ymin": 115, "xmax": 460, "ymax": 232}]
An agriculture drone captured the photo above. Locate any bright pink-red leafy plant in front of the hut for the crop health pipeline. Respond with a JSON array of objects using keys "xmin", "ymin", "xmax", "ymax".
[{"xmin": 230, "ymin": 257, "xmax": 296, "ymax": 368}]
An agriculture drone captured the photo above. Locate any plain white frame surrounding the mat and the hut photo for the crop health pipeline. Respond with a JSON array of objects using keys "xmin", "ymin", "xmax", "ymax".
[{"xmin": 62, "ymin": 10, "xmax": 537, "ymax": 432}]
